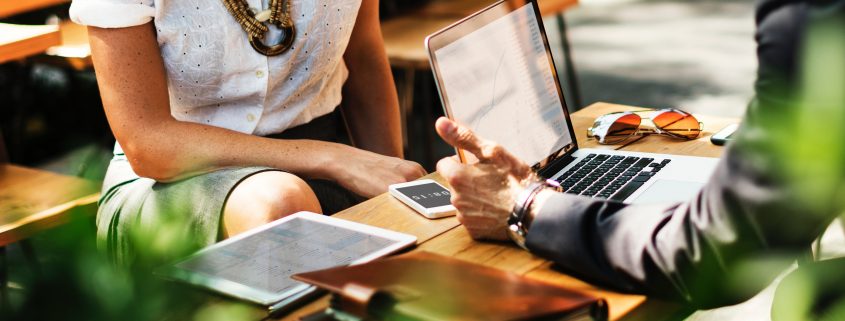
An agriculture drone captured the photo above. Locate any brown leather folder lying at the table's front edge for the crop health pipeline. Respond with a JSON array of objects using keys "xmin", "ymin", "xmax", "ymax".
[{"xmin": 293, "ymin": 251, "xmax": 607, "ymax": 320}]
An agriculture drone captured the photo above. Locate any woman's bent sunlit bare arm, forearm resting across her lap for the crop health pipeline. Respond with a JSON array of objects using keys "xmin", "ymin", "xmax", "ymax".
[{"xmin": 88, "ymin": 23, "xmax": 420, "ymax": 196}]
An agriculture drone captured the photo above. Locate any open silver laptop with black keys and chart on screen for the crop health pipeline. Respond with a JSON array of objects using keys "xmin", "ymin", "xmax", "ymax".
[{"xmin": 425, "ymin": 0, "xmax": 718, "ymax": 203}]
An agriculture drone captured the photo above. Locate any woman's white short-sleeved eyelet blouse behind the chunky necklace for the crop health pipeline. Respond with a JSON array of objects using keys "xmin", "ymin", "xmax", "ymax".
[{"xmin": 70, "ymin": 0, "xmax": 361, "ymax": 136}]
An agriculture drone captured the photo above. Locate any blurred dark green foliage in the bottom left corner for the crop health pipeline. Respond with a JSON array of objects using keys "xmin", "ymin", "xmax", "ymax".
[{"xmin": 0, "ymin": 208, "xmax": 260, "ymax": 321}]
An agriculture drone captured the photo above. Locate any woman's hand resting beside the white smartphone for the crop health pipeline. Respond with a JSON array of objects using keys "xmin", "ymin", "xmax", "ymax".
[{"xmin": 332, "ymin": 146, "xmax": 427, "ymax": 198}]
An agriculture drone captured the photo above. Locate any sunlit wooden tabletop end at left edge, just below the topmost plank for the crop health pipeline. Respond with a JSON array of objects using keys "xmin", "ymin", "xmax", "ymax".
[{"xmin": 0, "ymin": 23, "xmax": 62, "ymax": 64}]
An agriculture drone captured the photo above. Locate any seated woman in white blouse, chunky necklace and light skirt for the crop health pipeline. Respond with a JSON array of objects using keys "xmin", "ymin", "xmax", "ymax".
[{"xmin": 70, "ymin": 0, "xmax": 425, "ymax": 259}]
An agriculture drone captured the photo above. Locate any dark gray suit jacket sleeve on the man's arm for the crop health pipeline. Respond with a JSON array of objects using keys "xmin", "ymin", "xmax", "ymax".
[{"xmin": 527, "ymin": 1, "xmax": 845, "ymax": 307}]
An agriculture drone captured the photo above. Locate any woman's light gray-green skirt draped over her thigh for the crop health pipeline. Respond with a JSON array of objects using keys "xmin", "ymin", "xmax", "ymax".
[{"xmin": 97, "ymin": 149, "xmax": 273, "ymax": 264}]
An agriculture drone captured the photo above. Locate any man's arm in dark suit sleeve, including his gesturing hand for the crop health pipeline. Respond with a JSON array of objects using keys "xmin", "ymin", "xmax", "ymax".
[{"xmin": 437, "ymin": 1, "xmax": 845, "ymax": 308}]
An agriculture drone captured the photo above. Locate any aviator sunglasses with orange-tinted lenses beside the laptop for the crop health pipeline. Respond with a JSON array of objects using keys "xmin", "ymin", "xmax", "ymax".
[{"xmin": 587, "ymin": 108, "xmax": 701, "ymax": 144}]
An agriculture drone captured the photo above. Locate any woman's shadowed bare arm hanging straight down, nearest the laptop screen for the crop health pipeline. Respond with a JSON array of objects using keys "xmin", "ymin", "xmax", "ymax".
[{"xmin": 343, "ymin": 0, "xmax": 403, "ymax": 158}]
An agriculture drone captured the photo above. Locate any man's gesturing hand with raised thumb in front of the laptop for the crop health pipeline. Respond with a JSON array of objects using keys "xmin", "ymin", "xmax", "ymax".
[{"xmin": 435, "ymin": 117, "xmax": 535, "ymax": 240}]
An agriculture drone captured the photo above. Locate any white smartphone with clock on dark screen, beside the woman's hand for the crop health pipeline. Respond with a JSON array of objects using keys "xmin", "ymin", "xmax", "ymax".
[{"xmin": 388, "ymin": 179, "xmax": 456, "ymax": 219}]
